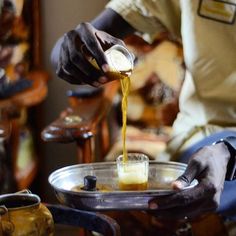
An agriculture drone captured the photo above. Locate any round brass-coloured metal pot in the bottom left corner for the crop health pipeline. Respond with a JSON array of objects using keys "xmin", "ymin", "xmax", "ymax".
[{"xmin": 0, "ymin": 190, "xmax": 54, "ymax": 236}]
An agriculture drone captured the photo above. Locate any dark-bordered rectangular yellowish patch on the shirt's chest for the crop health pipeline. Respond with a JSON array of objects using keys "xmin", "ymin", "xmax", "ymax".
[{"xmin": 198, "ymin": 0, "xmax": 236, "ymax": 24}]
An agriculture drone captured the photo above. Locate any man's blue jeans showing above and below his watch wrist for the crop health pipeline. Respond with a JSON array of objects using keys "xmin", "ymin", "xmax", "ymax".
[{"xmin": 180, "ymin": 130, "xmax": 236, "ymax": 220}]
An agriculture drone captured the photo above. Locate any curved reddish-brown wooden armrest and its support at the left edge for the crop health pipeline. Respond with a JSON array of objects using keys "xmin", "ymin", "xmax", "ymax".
[{"xmin": 0, "ymin": 71, "xmax": 48, "ymax": 190}]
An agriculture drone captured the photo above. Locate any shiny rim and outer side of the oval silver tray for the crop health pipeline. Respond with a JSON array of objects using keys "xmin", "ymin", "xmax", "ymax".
[{"xmin": 48, "ymin": 161, "xmax": 198, "ymax": 211}]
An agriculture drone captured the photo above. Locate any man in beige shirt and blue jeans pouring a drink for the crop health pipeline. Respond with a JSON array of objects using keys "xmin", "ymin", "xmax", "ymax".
[{"xmin": 52, "ymin": 0, "xmax": 236, "ymax": 218}]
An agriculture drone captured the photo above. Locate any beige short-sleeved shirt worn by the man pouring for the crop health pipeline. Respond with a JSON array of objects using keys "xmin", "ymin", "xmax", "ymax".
[{"xmin": 107, "ymin": 0, "xmax": 236, "ymax": 155}]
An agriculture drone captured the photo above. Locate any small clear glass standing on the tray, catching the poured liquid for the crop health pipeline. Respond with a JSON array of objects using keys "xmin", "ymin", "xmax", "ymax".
[{"xmin": 116, "ymin": 153, "xmax": 149, "ymax": 191}]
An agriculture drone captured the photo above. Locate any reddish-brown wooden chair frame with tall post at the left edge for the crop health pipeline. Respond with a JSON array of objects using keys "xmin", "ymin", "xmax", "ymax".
[{"xmin": 0, "ymin": 0, "xmax": 49, "ymax": 192}]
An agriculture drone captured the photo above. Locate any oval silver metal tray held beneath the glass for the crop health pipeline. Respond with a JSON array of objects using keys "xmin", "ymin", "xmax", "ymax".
[{"xmin": 49, "ymin": 161, "xmax": 197, "ymax": 211}]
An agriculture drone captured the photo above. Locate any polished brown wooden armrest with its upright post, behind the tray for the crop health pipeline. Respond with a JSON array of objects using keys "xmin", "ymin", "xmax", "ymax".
[{"xmin": 41, "ymin": 81, "xmax": 119, "ymax": 163}]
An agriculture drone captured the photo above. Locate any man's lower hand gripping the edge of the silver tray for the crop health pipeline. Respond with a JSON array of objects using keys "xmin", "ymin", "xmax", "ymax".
[{"xmin": 149, "ymin": 143, "xmax": 230, "ymax": 219}]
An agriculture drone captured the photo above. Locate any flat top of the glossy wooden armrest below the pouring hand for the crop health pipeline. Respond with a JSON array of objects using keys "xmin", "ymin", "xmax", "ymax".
[{"xmin": 41, "ymin": 82, "xmax": 119, "ymax": 143}]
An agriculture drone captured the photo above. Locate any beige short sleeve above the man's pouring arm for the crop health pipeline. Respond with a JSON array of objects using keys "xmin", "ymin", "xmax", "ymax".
[{"xmin": 106, "ymin": 0, "xmax": 180, "ymax": 41}]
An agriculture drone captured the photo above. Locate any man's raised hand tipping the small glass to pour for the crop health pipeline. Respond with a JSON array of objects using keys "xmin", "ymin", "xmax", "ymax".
[{"xmin": 56, "ymin": 23, "xmax": 124, "ymax": 87}]
